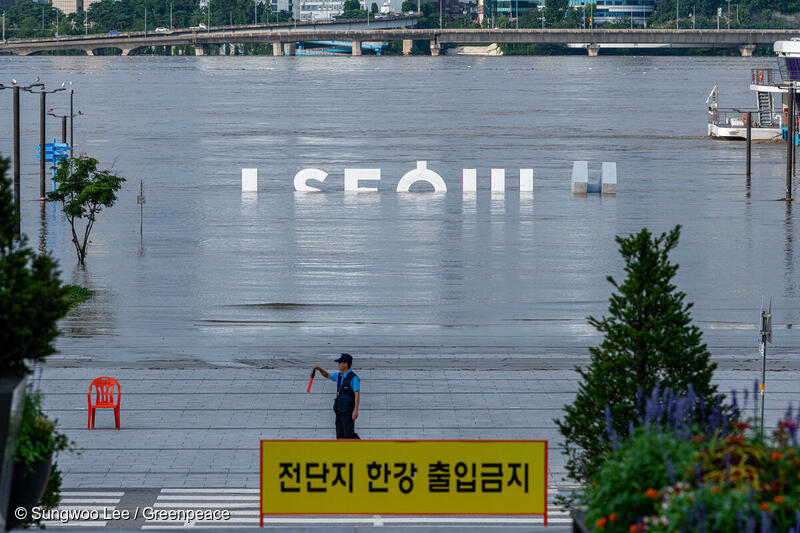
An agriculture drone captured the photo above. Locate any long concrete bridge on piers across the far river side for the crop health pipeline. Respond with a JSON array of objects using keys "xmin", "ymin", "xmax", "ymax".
[{"xmin": 0, "ymin": 25, "xmax": 800, "ymax": 56}]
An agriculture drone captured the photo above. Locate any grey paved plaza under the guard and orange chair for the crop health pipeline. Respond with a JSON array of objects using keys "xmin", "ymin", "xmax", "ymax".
[{"xmin": 26, "ymin": 359, "xmax": 800, "ymax": 530}]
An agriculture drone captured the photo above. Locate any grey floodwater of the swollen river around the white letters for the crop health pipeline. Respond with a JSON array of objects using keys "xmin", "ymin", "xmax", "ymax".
[{"xmin": 0, "ymin": 56, "xmax": 800, "ymax": 363}]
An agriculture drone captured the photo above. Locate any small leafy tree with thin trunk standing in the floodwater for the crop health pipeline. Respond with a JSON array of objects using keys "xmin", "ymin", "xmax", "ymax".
[{"xmin": 47, "ymin": 156, "xmax": 125, "ymax": 265}]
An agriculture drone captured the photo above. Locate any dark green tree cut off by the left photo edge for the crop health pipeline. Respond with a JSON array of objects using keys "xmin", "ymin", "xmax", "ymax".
[{"xmin": 0, "ymin": 158, "xmax": 69, "ymax": 377}]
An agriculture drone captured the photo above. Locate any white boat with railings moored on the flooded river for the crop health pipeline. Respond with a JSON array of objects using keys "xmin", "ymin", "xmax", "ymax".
[{"xmin": 706, "ymin": 39, "xmax": 800, "ymax": 141}]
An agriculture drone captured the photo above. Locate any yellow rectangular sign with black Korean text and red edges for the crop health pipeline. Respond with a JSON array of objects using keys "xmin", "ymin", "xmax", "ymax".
[{"xmin": 261, "ymin": 440, "xmax": 547, "ymax": 521}]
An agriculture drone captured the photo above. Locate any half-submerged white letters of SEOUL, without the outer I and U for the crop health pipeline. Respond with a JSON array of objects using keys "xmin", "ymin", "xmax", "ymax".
[{"xmin": 294, "ymin": 161, "xmax": 533, "ymax": 193}]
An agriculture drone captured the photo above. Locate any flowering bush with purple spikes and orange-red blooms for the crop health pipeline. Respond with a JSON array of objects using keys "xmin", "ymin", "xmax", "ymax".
[{"xmin": 580, "ymin": 391, "xmax": 800, "ymax": 533}]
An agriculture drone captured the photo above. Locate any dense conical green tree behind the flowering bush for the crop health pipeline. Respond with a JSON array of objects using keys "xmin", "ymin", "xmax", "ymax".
[{"xmin": 555, "ymin": 226, "xmax": 717, "ymax": 482}]
